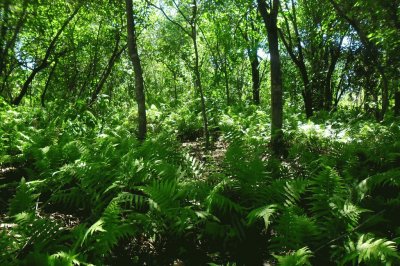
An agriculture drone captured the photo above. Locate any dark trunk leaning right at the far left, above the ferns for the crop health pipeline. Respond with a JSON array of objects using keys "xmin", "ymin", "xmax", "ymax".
[{"xmin": 13, "ymin": 5, "xmax": 82, "ymax": 105}]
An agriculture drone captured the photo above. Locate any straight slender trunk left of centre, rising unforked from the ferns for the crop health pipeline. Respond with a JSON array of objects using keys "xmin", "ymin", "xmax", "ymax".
[{"xmin": 125, "ymin": 0, "xmax": 147, "ymax": 141}]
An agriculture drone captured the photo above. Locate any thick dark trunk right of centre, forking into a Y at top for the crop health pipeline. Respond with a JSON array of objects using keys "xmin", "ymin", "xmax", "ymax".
[{"xmin": 257, "ymin": 0, "xmax": 285, "ymax": 155}]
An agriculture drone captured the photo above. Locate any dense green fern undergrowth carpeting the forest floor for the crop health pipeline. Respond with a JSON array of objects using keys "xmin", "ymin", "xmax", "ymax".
[{"xmin": 0, "ymin": 99, "xmax": 400, "ymax": 265}]
